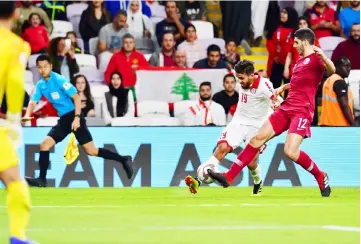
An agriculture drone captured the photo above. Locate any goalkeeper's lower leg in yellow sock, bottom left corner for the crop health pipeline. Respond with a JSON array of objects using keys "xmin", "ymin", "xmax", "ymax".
[{"xmin": 0, "ymin": 167, "xmax": 32, "ymax": 244}]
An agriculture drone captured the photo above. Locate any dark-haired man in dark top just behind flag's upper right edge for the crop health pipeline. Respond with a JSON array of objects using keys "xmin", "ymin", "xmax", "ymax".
[{"xmin": 193, "ymin": 44, "xmax": 229, "ymax": 69}]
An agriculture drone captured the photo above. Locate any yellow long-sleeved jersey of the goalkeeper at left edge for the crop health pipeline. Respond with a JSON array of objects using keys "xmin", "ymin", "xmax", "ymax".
[{"xmin": 0, "ymin": 26, "xmax": 30, "ymax": 130}]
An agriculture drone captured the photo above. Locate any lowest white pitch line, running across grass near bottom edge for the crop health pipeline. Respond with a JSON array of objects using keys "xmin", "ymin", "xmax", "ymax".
[{"xmin": 0, "ymin": 225, "xmax": 360, "ymax": 232}]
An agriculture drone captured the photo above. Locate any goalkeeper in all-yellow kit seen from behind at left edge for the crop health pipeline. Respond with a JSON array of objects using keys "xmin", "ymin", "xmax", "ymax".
[{"xmin": 0, "ymin": 1, "xmax": 36, "ymax": 244}]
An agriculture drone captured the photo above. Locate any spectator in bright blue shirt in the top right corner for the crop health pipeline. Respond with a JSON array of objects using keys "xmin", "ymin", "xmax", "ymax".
[{"xmin": 340, "ymin": 0, "xmax": 360, "ymax": 37}]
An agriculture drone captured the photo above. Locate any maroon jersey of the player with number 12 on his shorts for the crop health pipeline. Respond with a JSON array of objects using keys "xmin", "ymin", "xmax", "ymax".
[{"xmin": 280, "ymin": 53, "xmax": 325, "ymax": 113}]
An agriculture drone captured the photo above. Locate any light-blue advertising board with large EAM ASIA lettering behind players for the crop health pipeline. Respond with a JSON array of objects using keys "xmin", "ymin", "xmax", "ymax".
[{"xmin": 9, "ymin": 127, "xmax": 360, "ymax": 188}]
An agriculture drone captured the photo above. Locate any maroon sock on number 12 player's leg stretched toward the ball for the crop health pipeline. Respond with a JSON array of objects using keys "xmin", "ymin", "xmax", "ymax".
[{"xmin": 226, "ymin": 144, "xmax": 259, "ymax": 183}]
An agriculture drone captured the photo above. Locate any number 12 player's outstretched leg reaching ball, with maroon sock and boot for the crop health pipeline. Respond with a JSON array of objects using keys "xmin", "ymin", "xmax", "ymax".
[{"xmin": 208, "ymin": 120, "xmax": 275, "ymax": 187}]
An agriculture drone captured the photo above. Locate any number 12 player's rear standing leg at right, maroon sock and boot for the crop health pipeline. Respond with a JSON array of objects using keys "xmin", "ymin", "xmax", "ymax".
[{"xmin": 284, "ymin": 133, "xmax": 331, "ymax": 197}]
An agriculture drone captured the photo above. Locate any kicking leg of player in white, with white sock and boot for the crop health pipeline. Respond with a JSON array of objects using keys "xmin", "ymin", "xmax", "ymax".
[{"xmin": 184, "ymin": 142, "xmax": 231, "ymax": 194}]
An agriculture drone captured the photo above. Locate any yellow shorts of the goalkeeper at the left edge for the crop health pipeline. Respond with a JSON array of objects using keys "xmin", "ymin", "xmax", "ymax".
[{"xmin": 0, "ymin": 131, "xmax": 19, "ymax": 173}]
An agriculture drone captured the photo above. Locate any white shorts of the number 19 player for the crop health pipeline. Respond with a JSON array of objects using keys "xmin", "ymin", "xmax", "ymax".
[{"xmin": 217, "ymin": 122, "xmax": 259, "ymax": 151}]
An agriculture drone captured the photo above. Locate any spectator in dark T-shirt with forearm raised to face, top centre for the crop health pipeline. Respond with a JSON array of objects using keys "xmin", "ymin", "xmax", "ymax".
[{"xmin": 155, "ymin": 1, "xmax": 188, "ymax": 46}]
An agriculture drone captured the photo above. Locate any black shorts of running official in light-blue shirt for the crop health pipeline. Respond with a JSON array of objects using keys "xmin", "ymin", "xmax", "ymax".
[{"xmin": 48, "ymin": 111, "xmax": 93, "ymax": 145}]
